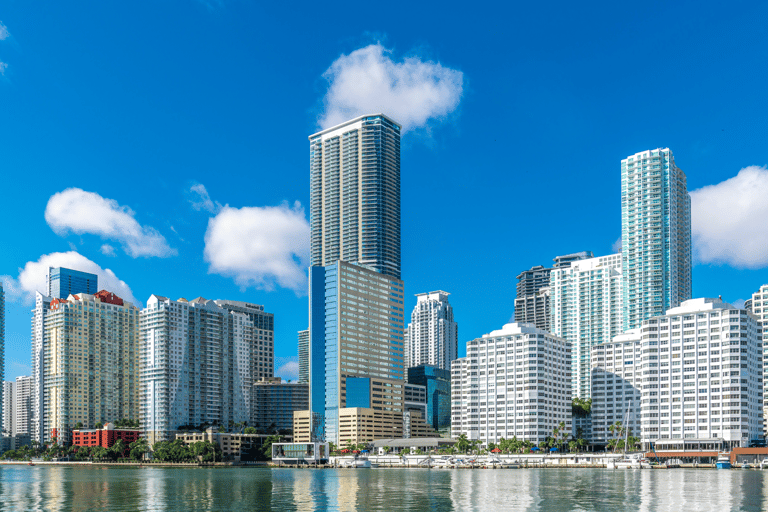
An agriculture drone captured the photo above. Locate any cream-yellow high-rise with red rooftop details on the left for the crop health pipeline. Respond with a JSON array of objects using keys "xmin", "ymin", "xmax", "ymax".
[{"xmin": 43, "ymin": 290, "xmax": 140, "ymax": 445}]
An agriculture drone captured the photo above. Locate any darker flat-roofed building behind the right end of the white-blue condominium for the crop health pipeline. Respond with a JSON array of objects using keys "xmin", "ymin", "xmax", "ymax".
[{"xmin": 213, "ymin": 300, "xmax": 275, "ymax": 382}]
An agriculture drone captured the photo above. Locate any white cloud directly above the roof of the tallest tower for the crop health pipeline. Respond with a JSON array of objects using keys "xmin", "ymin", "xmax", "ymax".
[{"xmin": 319, "ymin": 44, "xmax": 464, "ymax": 132}]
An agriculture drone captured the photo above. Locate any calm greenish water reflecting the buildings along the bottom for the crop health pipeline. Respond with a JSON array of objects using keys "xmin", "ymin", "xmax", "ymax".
[{"xmin": 0, "ymin": 466, "xmax": 768, "ymax": 512}]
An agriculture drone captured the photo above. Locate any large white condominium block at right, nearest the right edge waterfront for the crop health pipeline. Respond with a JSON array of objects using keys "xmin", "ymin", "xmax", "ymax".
[{"xmin": 641, "ymin": 299, "xmax": 763, "ymax": 449}]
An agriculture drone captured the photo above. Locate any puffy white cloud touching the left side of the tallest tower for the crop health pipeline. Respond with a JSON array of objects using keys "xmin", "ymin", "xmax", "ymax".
[{"xmin": 204, "ymin": 201, "xmax": 309, "ymax": 294}]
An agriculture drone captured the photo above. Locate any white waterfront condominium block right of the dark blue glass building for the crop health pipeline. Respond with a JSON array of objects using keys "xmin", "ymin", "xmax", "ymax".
[{"xmin": 451, "ymin": 323, "xmax": 571, "ymax": 446}]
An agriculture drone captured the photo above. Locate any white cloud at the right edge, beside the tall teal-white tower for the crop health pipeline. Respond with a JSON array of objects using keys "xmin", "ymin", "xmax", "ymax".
[{"xmin": 691, "ymin": 165, "xmax": 768, "ymax": 269}]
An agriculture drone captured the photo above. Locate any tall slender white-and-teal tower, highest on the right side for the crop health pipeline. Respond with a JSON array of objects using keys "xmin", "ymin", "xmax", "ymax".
[{"xmin": 621, "ymin": 148, "xmax": 692, "ymax": 329}]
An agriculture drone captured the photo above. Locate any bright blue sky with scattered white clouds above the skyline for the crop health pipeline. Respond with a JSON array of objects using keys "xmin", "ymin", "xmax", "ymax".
[{"xmin": 0, "ymin": 0, "xmax": 768, "ymax": 380}]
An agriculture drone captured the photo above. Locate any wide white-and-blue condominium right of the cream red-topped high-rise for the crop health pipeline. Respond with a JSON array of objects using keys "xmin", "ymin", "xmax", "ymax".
[{"xmin": 140, "ymin": 295, "xmax": 256, "ymax": 444}]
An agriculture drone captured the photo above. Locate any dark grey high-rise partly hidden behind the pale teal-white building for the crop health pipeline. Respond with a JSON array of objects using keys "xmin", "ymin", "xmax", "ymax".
[{"xmin": 515, "ymin": 251, "xmax": 593, "ymax": 331}]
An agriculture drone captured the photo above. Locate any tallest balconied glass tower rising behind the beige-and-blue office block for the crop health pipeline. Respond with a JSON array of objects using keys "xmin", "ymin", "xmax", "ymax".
[{"xmin": 309, "ymin": 114, "xmax": 400, "ymax": 279}]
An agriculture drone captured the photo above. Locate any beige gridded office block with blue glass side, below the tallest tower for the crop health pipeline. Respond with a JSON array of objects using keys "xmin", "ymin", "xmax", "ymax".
[{"xmin": 309, "ymin": 261, "xmax": 405, "ymax": 444}]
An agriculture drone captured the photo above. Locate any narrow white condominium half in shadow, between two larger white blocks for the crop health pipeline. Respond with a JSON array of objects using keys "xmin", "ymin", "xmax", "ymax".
[{"xmin": 592, "ymin": 328, "xmax": 643, "ymax": 445}]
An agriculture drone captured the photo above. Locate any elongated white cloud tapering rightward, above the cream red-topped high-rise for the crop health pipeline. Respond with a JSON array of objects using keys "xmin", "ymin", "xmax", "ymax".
[{"xmin": 45, "ymin": 188, "xmax": 177, "ymax": 258}]
